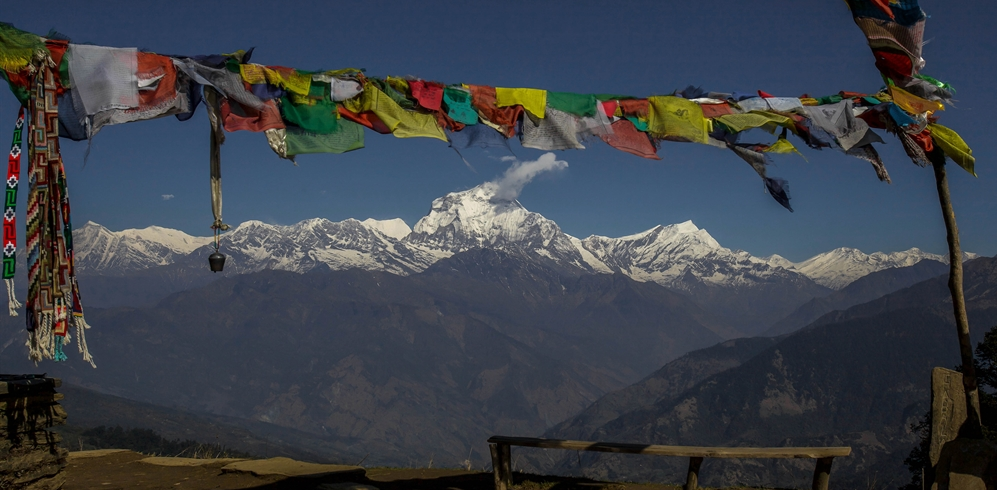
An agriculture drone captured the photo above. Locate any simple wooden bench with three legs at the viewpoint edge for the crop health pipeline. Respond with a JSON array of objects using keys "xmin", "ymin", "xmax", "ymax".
[{"xmin": 488, "ymin": 436, "xmax": 852, "ymax": 490}]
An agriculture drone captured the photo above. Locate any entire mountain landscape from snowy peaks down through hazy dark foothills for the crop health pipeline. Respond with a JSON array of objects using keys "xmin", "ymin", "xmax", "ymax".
[{"xmin": 7, "ymin": 184, "xmax": 989, "ymax": 483}]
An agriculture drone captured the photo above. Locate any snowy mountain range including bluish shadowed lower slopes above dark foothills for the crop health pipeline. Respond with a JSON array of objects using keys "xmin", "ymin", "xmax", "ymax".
[{"xmin": 74, "ymin": 183, "xmax": 975, "ymax": 337}]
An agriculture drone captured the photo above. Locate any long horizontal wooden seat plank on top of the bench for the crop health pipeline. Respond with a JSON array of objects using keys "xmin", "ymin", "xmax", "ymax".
[{"xmin": 488, "ymin": 436, "xmax": 852, "ymax": 459}]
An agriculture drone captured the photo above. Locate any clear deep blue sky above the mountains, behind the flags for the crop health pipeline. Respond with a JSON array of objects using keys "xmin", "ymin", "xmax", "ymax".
[{"xmin": 0, "ymin": 0, "xmax": 997, "ymax": 260}]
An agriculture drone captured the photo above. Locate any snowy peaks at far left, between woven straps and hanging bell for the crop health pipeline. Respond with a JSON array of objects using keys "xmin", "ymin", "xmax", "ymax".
[{"xmin": 73, "ymin": 221, "xmax": 211, "ymax": 275}]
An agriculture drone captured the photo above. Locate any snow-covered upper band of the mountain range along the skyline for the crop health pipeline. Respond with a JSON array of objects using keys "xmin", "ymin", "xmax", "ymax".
[{"xmin": 74, "ymin": 182, "xmax": 976, "ymax": 290}]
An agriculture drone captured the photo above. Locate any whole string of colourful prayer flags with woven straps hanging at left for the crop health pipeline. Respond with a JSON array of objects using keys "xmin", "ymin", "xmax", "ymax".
[{"xmin": 0, "ymin": 0, "xmax": 975, "ymax": 362}]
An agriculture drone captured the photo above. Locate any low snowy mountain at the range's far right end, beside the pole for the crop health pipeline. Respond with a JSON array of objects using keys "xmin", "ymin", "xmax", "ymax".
[{"xmin": 766, "ymin": 247, "xmax": 977, "ymax": 290}]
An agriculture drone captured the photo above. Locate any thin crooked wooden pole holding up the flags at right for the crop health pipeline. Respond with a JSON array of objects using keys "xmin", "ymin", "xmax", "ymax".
[{"xmin": 929, "ymin": 155, "xmax": 983, "ymax": 439}]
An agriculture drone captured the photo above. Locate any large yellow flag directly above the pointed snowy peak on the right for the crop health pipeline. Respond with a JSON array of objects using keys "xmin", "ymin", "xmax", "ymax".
[{"xmin": 647, "ymin": 95, "xmax": 710, "ymax": 144}]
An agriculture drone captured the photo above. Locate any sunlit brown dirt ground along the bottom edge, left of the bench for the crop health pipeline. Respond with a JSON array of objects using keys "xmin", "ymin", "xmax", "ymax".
[{"xmin": 63, "ymin": 451, "xmax": 776, "ymax": 490}]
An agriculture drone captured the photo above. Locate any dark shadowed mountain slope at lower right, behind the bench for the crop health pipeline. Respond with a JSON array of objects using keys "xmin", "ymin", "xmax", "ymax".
[{"xmin": 520, "ymin": 258, "xmax": 997, "ymax": 488}]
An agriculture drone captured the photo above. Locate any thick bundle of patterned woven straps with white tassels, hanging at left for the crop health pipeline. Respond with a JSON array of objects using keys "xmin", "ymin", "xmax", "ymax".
[{"xmin": 27, "ymin": 60, "xmax": 96, "ymax": 367}]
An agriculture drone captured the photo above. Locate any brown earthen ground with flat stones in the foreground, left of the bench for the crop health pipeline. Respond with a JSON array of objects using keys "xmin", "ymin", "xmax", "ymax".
[{"xmin": 63, "ymin": 449, "xmax": 792, "ymax": 490}]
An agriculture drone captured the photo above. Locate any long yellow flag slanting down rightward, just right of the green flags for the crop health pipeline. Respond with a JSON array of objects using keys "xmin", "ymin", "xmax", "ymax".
[{"xmin": 343, "ymin": 82, "xmax": 449, "ymax": 141}]
